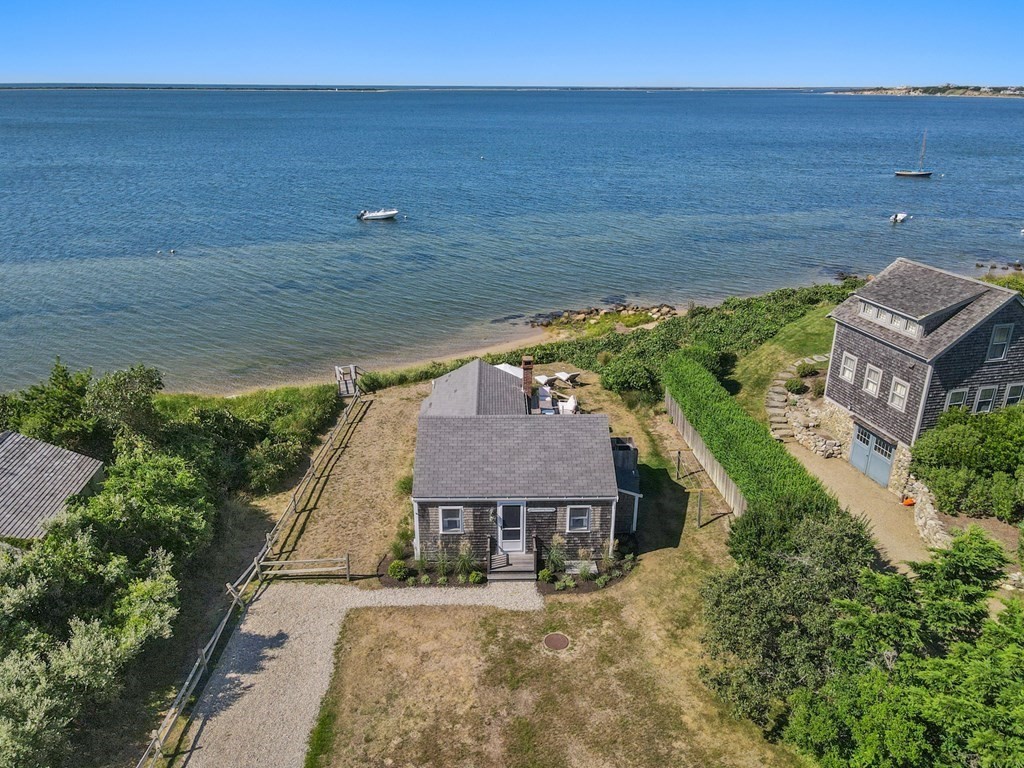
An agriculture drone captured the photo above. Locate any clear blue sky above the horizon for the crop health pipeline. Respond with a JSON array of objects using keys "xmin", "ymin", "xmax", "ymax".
[{"xmin": 0, "ymin": 0, "xmax": 1024, "ymax": 86}]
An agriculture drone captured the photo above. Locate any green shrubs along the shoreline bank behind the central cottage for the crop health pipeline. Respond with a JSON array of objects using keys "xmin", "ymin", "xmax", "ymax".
[{"xmin": 359, "ymin": 280, "xmax": 861, "ymax": 398}]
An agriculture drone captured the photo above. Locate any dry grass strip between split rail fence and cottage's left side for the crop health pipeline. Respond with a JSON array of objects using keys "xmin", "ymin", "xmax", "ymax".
[{"xmin": 290, "ymin": 382, "xmax": 430, "ymax": 574}]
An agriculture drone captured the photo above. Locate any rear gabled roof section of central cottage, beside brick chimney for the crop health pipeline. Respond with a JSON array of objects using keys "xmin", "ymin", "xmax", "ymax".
[{"xmin": 420, "ymin": 357, "xmax": 526, "ymax": 416}]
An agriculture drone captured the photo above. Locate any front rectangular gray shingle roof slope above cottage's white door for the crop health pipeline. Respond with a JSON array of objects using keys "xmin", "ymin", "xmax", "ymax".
[{"xmin": 413, "ymin": 414, "xmax": 618, "ymax": 501}]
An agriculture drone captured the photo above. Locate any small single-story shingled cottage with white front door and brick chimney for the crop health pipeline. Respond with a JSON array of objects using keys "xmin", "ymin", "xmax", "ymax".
[{"xmin": 413, "ymin": 358, "xmax": 640, "ymax": 579}]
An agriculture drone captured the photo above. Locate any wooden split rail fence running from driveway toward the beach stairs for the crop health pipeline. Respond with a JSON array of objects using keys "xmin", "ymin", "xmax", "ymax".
[{"xmin": 136, "ymin": 380, "xmax": 362, "ymax": 768}]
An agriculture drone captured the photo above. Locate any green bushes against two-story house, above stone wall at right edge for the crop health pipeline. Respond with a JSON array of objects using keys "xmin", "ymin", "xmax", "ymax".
[{"xmin": 911, "ymin": 406, "xmax": 1024, "ymax": 522}]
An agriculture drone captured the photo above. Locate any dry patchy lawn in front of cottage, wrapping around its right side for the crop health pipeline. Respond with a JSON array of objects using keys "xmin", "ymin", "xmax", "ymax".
[{"xmin": 307, "ymin": 397, "xmax": 805, "ymax": 768}]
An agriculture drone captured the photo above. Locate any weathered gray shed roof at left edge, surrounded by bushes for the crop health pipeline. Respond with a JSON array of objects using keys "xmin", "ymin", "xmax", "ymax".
[{"xmin": 0, "ymin": 431, "xmax": 103, "ymax": 539}]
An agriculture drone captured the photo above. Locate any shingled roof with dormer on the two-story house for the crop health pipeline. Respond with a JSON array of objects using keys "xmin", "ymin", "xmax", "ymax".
[{"xmin": 831, "ymin": 259, "xmax": 1020, "ymax": 361}]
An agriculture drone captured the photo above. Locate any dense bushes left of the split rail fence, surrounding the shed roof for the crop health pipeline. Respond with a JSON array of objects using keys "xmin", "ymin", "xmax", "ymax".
[{"xmin": 0, "ymin": 361, "xmax": 336, "ymax": 768}]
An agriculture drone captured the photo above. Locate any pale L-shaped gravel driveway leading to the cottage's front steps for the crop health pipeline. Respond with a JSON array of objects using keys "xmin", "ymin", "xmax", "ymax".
[{"xmin": 180, "ymin": 582, "xmax": 544, "ymax": 768}]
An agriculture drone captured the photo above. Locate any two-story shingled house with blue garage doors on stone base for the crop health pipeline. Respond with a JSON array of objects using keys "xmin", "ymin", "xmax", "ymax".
[{"xmin": 822, "ymin": 259, "xmax": 1024, "ymax": 492}]
